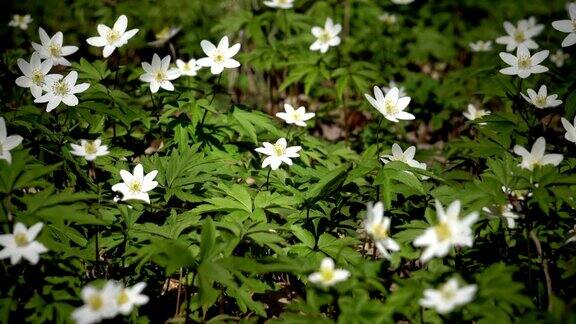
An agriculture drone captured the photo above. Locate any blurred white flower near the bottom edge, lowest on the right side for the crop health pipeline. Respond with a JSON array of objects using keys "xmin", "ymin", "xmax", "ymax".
[{"xmin": 420, "ymin": 278, "xmax": 477, "ymax": 314}]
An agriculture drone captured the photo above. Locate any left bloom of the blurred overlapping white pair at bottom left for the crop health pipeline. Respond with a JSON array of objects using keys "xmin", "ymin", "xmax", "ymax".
[{"xmin": 72, "ymin": 281, "xmax": 118, "ymax": 324}]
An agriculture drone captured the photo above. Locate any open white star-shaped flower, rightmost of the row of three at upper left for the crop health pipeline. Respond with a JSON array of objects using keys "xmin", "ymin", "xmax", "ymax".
[{"xmin": 196, "ymin": 36, "xmax": 240, "ymax": 74}]
